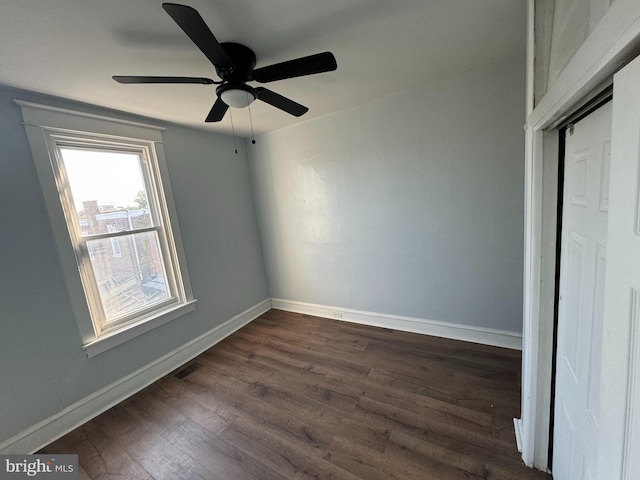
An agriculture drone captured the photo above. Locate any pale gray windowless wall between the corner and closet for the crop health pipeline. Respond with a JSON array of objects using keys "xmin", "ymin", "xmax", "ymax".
[{"xmin": 249, "ymin": 57, "xmax": 525, "ymax": 332}]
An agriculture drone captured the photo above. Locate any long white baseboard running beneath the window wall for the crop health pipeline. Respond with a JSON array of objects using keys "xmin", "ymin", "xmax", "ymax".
[{"xmin": 0, "ymin": 298, "xmax": 271, "ymax": 454}]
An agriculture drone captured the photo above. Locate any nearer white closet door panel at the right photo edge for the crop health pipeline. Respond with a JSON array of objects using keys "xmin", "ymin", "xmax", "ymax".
[{"xmin": 598, "ymin": 52, "xmax": 640, "ymax": 480}]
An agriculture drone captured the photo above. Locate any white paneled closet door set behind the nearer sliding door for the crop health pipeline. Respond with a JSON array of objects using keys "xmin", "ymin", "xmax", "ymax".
[{"xmin": 553, "ymin": 102, "xmax": 612, "ymax": 480}]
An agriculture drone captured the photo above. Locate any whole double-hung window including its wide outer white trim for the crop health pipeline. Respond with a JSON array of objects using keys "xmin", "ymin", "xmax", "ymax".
[{"xmin": 17, "ymin": 101, "xmax": 195, "ymax": 356}]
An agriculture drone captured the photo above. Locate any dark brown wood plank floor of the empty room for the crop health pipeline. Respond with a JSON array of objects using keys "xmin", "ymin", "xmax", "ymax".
[{"xmin": 41, "ymin": 310, "xmax": 551, "ymax": 480}]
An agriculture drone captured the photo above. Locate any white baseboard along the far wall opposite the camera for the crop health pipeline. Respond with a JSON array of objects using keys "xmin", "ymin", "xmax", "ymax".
[{"xmin": 271, "ymin": 298, "xmax": 522, "ymax": 350}]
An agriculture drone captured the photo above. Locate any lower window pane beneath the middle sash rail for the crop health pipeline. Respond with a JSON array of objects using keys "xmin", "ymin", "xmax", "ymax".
[{"xmin": 87, "ymin": 232, "xmax": 171, "ymax": 322}]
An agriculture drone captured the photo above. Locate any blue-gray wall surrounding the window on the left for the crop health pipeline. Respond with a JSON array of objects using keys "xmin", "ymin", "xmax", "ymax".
[{"xmin": 0, "ymin": 88, "xmax": 269, "ymax": 442}]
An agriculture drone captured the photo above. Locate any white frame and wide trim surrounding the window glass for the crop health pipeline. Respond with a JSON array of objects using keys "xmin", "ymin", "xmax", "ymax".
[{"xmin": 15, "ymin": 100, "xmax": 196, "ymax": 357}]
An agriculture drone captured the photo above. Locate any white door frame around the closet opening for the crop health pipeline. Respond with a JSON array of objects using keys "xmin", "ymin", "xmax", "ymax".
[{"xmin": 514, "ymin": 0, "xmax": 640, "ymax": 470}]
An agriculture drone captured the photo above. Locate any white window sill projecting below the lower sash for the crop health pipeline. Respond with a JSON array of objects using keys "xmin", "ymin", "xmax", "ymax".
[{"xmin": 82, "ymin": 300, "xmax": 197, "ymax": 358}]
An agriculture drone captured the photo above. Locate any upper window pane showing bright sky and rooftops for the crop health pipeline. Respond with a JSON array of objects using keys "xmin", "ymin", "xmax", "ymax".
[{"xmin": 60, "ymin": 148, "xmax": 153, "ymax": 236}]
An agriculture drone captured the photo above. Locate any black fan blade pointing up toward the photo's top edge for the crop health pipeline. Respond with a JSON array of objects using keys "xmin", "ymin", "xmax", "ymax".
[{"xmin": 162, "ymin": 3, "xmax": 233, "ymax": 70}]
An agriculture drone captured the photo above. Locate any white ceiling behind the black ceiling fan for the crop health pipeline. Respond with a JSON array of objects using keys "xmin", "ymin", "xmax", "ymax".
[{"xmin": 0, "ymin": 0, "xmax": 526, "ymax": 136}]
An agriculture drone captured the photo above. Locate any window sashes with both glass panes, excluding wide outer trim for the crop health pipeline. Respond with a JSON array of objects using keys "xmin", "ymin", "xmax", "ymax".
[{"xmin": 54, "ymin": 142, "xmax": 178, "ymax": 330}]
